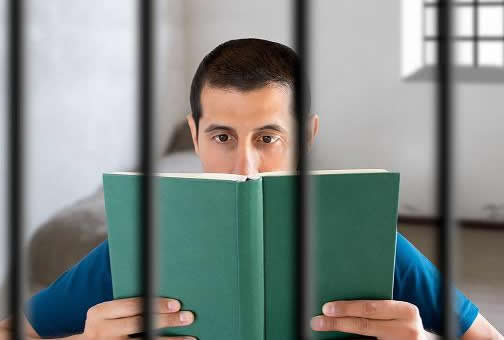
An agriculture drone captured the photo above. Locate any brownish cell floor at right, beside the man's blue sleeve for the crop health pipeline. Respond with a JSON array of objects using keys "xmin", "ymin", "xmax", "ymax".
[{"xmin": 399, "ymin": 224, "xmax": 504, "ymax": 334}]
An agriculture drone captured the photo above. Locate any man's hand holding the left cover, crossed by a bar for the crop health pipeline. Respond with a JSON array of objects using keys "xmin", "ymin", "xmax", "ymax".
[{"xmin": 82, "ymin": 298, "xmax": 195, "ymax": 340}]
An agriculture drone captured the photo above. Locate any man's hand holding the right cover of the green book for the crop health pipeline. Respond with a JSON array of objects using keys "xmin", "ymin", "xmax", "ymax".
[{"xmin": 311, "ymin": 300, "xmax": 426, "ymax": 340}]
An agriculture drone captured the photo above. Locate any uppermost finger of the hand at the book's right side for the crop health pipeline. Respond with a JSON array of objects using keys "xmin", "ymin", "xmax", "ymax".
[{"xmin": 322, "ymin": 300, "xmax": 418, "ymax": 320}]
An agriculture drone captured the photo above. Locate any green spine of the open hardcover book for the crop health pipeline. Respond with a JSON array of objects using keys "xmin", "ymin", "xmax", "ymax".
[{"xmin": 236, "ymin": 179, "xmax": 264, "ymax": 340}]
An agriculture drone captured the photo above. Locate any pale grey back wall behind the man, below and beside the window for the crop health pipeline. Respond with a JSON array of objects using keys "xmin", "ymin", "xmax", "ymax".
[{"xmin": 185, "ymin": 0, "xmax": 504, "ymax": 218}]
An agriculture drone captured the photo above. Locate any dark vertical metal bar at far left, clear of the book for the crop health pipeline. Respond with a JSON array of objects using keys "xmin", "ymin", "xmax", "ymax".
[{"xmin": 7, "ymin": 0, "xmax": 24, "ymax": 340}]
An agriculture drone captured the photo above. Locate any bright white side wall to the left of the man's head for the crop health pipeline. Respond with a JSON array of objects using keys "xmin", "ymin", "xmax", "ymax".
[{"xmin": 0, "ymin": 0, "xmax": 185, "ymax": 313}]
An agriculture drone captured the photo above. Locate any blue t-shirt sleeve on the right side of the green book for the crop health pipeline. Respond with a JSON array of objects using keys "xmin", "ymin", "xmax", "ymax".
[{"xmin": 394, "ymin": 233, "xmax": 479, "ymax": 336}]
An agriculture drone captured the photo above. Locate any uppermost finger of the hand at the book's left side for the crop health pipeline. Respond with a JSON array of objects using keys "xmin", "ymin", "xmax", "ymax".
[{"xmin": 88, "ymin": 297, "xmax": 180, "ymax": 319}]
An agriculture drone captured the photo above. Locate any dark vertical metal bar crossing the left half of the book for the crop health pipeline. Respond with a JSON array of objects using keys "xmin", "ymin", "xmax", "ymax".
[{"xmin": 138, "ymin": 0, "xmax": 154, "ymax": 340}]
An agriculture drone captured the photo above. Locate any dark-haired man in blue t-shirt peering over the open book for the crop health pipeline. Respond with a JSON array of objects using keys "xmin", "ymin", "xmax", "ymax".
[{"xmin": 0, "ymin": 39, "xmax": 503, "ymax": 340}]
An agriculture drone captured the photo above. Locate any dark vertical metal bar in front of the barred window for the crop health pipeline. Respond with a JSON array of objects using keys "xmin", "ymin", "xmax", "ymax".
[{"xmin": 437, "ymin": 0, "xmax": 456, "ymax": 339}]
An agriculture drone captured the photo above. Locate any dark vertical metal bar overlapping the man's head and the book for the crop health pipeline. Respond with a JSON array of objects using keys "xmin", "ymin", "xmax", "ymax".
[{"xmin": 294, "ymin": 0, "xmax": 311, "ymax": 339}]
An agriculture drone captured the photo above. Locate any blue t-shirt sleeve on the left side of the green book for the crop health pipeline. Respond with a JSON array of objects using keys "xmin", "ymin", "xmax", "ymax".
[{"xmin": 25, "ymin": 241, "xmax": 113, "ymax": 337}]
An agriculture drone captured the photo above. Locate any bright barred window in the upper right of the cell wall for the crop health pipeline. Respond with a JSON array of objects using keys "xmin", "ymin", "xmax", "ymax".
[{"xmin": 402, "ymin": 0, "xmax": 504, "ymax": 81}]
